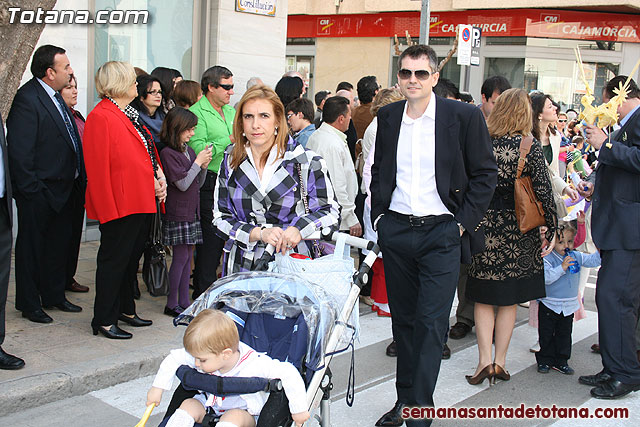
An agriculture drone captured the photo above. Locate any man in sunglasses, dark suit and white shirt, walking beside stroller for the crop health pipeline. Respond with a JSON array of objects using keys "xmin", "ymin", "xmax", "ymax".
[{"xmin": 371, "ymin": 45, "xmax": 497, "ymax": 426}]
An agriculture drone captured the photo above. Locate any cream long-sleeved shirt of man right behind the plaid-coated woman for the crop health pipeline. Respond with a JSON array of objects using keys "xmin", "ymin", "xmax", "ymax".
[{"xmin": 307, "ymin": 122, "xmax": 358, "ymax": 230}]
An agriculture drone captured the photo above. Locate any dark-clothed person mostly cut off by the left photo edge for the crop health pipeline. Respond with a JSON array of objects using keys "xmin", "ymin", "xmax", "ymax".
[{"xmin": 0, "ymin": 117, "xmax": 24, "ymax": 369}]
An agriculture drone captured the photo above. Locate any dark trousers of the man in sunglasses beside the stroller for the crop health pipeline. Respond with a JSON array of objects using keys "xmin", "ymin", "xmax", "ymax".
[{"xmin": 377, "ymin": 211, "xmax": 460, "ymax": 426}]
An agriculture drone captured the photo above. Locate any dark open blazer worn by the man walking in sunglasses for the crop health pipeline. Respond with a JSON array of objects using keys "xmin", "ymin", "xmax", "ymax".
[{"xmin": 370, "ymin": 98, "xmax": 498, "ymax": 264}]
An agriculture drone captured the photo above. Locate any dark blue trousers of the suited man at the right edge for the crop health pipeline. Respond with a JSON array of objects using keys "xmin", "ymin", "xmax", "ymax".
[{"xmin": 596, "ymin": 247, "xmax": 640, "ymax": 384}]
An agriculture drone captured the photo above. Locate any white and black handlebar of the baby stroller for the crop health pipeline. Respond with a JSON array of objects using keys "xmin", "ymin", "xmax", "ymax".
[{"xmin": 255, "ymin": 228, "xmax": 380, "ymax": 288}]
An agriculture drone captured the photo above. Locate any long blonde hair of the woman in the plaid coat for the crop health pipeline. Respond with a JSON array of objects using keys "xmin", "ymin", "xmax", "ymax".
[{"xmin": 231, "ymin": 85, "xmax": 289, "ymax": 169}]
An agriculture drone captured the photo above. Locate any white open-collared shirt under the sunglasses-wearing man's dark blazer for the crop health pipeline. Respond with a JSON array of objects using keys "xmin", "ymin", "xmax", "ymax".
[{"xmin": 389, "ymin": 94, "xmax": 453, "ymax": 216}]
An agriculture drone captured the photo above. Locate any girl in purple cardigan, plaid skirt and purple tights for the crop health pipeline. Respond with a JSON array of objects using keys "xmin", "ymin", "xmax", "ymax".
[{"xmin": 160, "ymin": 107, "xmax": 212, "ymax": 317}]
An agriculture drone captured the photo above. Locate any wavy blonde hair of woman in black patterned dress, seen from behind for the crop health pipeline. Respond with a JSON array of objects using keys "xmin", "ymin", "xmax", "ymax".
[{"xmin": 487, "ymin": 88, "xmax": 533, "ymax": 138}]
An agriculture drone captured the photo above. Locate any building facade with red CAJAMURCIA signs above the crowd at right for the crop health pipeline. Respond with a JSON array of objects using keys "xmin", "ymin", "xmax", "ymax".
[{"xmin": 287, "ymin": 0, "xmax": 640, "ymax": 108}]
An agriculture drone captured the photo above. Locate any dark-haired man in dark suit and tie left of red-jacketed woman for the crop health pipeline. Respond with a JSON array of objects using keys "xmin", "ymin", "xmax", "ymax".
[{"xmin": 7, "ymin": 45, "xmax": 86, "ymax": 323}]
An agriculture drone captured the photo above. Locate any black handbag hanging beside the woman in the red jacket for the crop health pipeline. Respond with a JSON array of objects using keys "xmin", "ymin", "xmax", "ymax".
[{"xmin": 142, "ymin": 201, "xmax": 169, "ymax": 297}]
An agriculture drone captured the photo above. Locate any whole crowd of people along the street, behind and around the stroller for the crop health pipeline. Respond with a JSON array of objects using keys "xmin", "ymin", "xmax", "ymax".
[{"xmin": 0, "ymin": 45, "xmax": 640, "ymax": 426}]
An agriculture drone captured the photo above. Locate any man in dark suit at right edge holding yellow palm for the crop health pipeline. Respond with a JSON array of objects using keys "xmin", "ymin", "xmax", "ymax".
[{"xmin": 579, "ymin": 76, "xmax": 640, "ymax": 399}]
